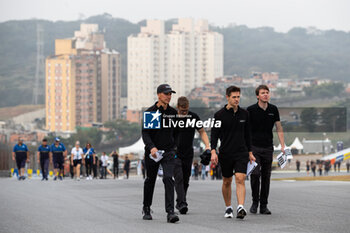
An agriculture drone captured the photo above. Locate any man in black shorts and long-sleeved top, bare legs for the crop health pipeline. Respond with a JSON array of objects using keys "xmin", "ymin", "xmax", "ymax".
[{"xmin": 211, "ymin": 86, "xmax": 255, "ymax": 219}]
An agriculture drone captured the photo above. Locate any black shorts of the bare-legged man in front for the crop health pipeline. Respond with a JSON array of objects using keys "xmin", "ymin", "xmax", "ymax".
[{"xmin": 219, "ymin": 152, "xmax": 249, "ymax": 178}]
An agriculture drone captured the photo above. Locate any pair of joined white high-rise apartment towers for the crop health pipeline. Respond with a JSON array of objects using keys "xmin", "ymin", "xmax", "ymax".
[{"xmin": 127, "ymin": 19, "xmax": 223, "ymax": 110}]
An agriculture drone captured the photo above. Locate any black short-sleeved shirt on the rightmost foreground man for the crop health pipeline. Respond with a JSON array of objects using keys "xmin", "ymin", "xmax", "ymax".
[{"xmin": 247, "ymin": 103, "xmax": 280, "ymax": 147}]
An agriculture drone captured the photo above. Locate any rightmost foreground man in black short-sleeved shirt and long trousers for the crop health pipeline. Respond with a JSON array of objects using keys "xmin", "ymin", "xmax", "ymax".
[{"xmin": 247, "ymin": 85, "xmax": 285, "ymax": 214}]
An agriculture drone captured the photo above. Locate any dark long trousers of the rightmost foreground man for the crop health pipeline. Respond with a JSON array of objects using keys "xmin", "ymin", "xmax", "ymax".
[{"xmin": 250, "ymin": 146, "xmax": 273, "ymax": 206}]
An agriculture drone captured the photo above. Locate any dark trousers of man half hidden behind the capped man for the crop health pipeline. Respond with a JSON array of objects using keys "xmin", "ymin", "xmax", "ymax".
[{"xmin": 174, "ymin": 157, "xmax": 193, "ymax": 207}]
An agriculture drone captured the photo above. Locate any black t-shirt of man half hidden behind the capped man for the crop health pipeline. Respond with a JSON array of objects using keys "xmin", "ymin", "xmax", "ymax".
[{"xmin": 176, "ymin": 111, "xmax": 202, "ymax": 158}]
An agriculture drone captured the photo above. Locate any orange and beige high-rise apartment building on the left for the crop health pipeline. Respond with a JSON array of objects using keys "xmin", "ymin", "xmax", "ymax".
[{"xmin": 46, "ymin": 24, "xmax": 121, "ymax": 132}]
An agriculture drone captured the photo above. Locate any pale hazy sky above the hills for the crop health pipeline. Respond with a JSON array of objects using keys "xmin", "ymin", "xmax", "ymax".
[{"xmin": 0, "ymin": 0, "xmax": 350, "ymax": 32}]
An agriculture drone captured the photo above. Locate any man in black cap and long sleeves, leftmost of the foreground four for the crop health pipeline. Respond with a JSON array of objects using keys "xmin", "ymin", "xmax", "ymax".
[{"xmin": 142, "ymin": 84, "xmax": 179, "ymax": 223}]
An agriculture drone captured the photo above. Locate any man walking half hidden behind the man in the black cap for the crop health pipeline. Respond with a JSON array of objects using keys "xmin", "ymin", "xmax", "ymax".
[{"xmin": 174, "ymin": 96, "xmax": 210, "ymax": 214}]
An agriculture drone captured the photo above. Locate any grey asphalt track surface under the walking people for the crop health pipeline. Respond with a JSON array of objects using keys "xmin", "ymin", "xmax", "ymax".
[{"xmin": 0, "ymin": 174, "xmax": 350, "ymax": 233}]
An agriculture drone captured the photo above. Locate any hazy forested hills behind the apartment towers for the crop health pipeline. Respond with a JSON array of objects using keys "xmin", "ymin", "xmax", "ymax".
[{"xmin": 0, "ymin": 14, "xmax": 350, "ymax": 107}]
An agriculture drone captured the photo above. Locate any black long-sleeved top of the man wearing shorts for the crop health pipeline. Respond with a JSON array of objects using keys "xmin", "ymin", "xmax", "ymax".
[{"xmin": 210, "ymin": 105, "xmax": 251, "ymax": 157}]
